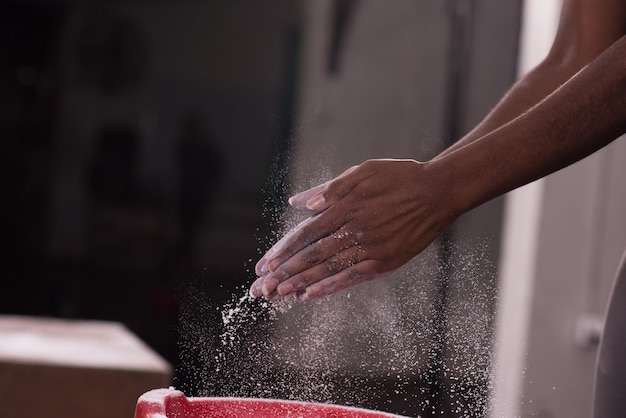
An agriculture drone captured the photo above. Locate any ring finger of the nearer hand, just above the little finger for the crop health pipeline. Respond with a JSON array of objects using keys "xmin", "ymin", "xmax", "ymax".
[{"xmin": 276, "ymin": 244, "xmax": 365, "ymax": 297}]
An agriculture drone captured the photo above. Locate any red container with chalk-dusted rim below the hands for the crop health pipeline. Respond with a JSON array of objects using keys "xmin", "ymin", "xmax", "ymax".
[{"xmin": 135, "ymin": 389, "xmax": 399, "ymax": 418}]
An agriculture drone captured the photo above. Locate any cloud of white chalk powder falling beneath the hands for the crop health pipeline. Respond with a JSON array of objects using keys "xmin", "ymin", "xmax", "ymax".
[{"xmin": 180, "ymin": 164, "xmax": 496, "ymax": 417}]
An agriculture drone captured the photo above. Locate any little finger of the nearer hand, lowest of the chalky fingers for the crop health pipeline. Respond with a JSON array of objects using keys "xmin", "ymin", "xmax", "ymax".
[{"xmin": 298, "ymin": 260, "xmax": 391, "ymax": 301}]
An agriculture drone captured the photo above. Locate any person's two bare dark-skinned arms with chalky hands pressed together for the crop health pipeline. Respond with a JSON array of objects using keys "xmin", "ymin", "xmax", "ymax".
[{"xmin": 250, "ymin": 0, "xmax": 626, "ymax": 300}]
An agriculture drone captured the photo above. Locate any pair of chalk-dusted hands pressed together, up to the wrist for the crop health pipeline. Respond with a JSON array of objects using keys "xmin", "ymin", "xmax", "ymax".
[{"xmin": 250, "ymin": 160, "xmax": 456, "ymax": 300}]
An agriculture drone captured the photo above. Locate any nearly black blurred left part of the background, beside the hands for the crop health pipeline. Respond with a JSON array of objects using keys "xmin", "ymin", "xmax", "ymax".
[{"xmin": 0, "ymin": 0, "xmax": 299, "ymax": 386}]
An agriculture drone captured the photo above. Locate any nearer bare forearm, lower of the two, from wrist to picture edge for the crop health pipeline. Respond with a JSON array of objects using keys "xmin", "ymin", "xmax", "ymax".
[{"xmin": 429, "ymin": 38, "xmax": 626, "ymax": 214}]
